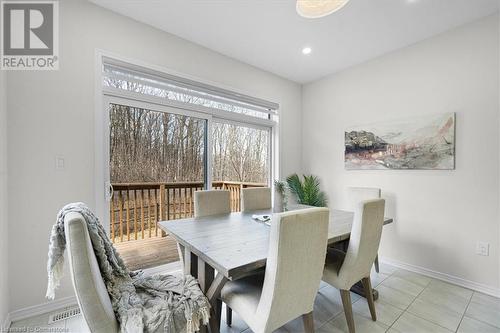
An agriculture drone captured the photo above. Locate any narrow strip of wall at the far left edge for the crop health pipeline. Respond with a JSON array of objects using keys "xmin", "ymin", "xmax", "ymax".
[{"xmin": 0, "ymin": 59, "xmax": 9, "ymax": 329}]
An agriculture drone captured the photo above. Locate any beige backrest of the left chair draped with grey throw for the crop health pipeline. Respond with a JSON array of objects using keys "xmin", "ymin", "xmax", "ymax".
[{"xmin": 64, "ymin": 212, "xmax": 119, "ymax": 333}]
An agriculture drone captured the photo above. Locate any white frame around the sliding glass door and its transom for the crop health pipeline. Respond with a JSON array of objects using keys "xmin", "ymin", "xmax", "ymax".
[{"xmin": 95, "ymin": 50, "xmax": 281, "ymax": 232}]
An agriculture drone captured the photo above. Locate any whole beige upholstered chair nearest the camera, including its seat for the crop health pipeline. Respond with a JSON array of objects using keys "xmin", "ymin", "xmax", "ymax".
[{"xmin": 221, "ymin": 208, "xmax": 329, "ymax": 333}]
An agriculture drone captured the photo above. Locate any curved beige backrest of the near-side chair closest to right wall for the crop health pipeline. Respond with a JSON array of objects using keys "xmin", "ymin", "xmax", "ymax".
[{"xmin": 339, "ymin": 199, "xmax": 385, "ymax": 288}]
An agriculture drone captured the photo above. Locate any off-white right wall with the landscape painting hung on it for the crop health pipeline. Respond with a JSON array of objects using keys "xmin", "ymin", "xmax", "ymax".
[{"xmin": 302, "ymin": 15, "xmax": 500, "ymax": 288}]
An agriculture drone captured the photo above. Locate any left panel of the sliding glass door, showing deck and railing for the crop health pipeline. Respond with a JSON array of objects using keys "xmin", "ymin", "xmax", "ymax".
[{"xmin": 107, "ymin": 98, "xmax": 209, "ymax": 270}]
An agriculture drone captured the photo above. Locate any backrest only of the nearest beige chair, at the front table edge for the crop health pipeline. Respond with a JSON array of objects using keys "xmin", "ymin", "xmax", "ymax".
[{"xmin": 256, "ymin": 208, "xmax": 329, "ymax": 332}]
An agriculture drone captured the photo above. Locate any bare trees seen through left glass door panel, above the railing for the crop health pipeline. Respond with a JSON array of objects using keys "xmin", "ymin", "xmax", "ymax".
[{"xmin": 109, "ymin": 104, "xmax": 206, "ymax": 184}]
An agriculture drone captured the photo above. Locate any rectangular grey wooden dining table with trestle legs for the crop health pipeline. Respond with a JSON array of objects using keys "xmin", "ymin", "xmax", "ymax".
[{"xmin": 159, "ymin": 205, "xmax": 393, "ymax": 333}]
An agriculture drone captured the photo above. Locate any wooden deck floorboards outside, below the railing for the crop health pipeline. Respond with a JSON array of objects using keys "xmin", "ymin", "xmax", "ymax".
[{"xmin": 113, "ymin": 236, "xmax": 179, "ymax": 270}]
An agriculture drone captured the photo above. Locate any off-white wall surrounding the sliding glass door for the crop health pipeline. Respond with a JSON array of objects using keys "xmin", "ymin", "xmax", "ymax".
[{"xmin": 8, "ymin": 0, "xmax": 301, "ymax": 310}]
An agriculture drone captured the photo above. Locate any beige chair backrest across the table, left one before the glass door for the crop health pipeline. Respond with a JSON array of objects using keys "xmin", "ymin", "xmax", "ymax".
[{"xmin": 194, "ymin": 190, "xmax": 231, "ymax": 217}]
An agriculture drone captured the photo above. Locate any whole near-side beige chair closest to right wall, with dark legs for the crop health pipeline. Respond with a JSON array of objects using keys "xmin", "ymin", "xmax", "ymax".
[{"xmin": 323, "ymin": 199, "xmax": 385, "ymax": 333}]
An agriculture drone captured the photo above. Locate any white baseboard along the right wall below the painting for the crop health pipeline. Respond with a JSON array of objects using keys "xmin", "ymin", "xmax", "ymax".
[{"xmin": 380, "ymin": 257, "xmax": 500, "ymax": 297}]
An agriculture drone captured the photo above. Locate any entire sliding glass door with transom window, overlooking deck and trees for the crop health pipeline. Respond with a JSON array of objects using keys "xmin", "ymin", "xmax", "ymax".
[{"xmin": 102, "ymin": 57, "xmax": 278, "ymax": 270}]
